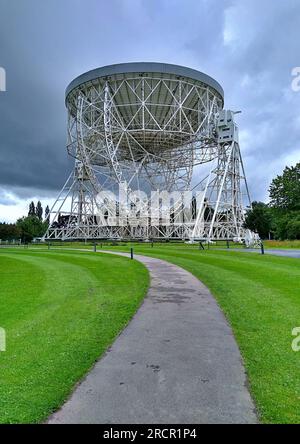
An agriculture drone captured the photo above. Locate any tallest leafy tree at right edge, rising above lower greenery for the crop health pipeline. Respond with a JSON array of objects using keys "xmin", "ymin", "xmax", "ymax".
[{"xmin": 269, "ymin": 163, "xmax": 300, "ymax": 211}]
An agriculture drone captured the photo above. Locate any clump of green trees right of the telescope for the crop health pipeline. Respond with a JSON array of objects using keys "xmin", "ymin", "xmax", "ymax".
[{"xmin": 245, "ymin": 163, "xmax": 300, "ymax": 240}]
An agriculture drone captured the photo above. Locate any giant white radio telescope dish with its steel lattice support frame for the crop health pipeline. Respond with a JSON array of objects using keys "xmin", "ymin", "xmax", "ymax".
[{"xmin": 45, "ymin": 63, "xmax": 250, "ymax": 241}]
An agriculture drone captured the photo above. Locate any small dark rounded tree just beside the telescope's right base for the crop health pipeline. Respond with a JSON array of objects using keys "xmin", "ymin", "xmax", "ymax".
[{"xmin": 244, "ymin": 202, "xmax": 272, "ymax": 239}]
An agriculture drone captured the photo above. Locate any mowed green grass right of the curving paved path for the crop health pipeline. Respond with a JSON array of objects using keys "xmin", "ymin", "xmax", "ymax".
[{"xmin": 99, "ymin": 244, "xmax": 300, "ymax": 423}]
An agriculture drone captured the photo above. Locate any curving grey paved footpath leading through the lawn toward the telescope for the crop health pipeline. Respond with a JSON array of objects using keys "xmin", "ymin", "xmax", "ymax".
[{"xmin": 48, "ymin": 256, "xmax": 257, "ymax": 424}]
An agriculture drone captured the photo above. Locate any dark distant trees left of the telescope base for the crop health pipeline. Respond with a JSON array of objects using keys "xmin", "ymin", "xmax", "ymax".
[{"xmin": 0, "ymin": 201, "xmax": 50, "ymax": 243}]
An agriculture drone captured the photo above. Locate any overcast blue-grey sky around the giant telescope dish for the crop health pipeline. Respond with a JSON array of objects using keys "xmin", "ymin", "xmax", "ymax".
[{"xmin": 0, "ymin": 0, "xmax": 300, "ymax": 221}]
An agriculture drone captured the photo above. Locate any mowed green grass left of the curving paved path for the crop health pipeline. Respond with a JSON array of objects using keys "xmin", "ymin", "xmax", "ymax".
[{"xmin": 0, "ymin": 249, "xmax": 149, "ymax": 423}]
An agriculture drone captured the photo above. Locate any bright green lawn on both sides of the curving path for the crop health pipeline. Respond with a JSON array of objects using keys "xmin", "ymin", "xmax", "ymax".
[{"xmin": 0, "ymin": 242, "xmax": 300, "ymax": 423}]
